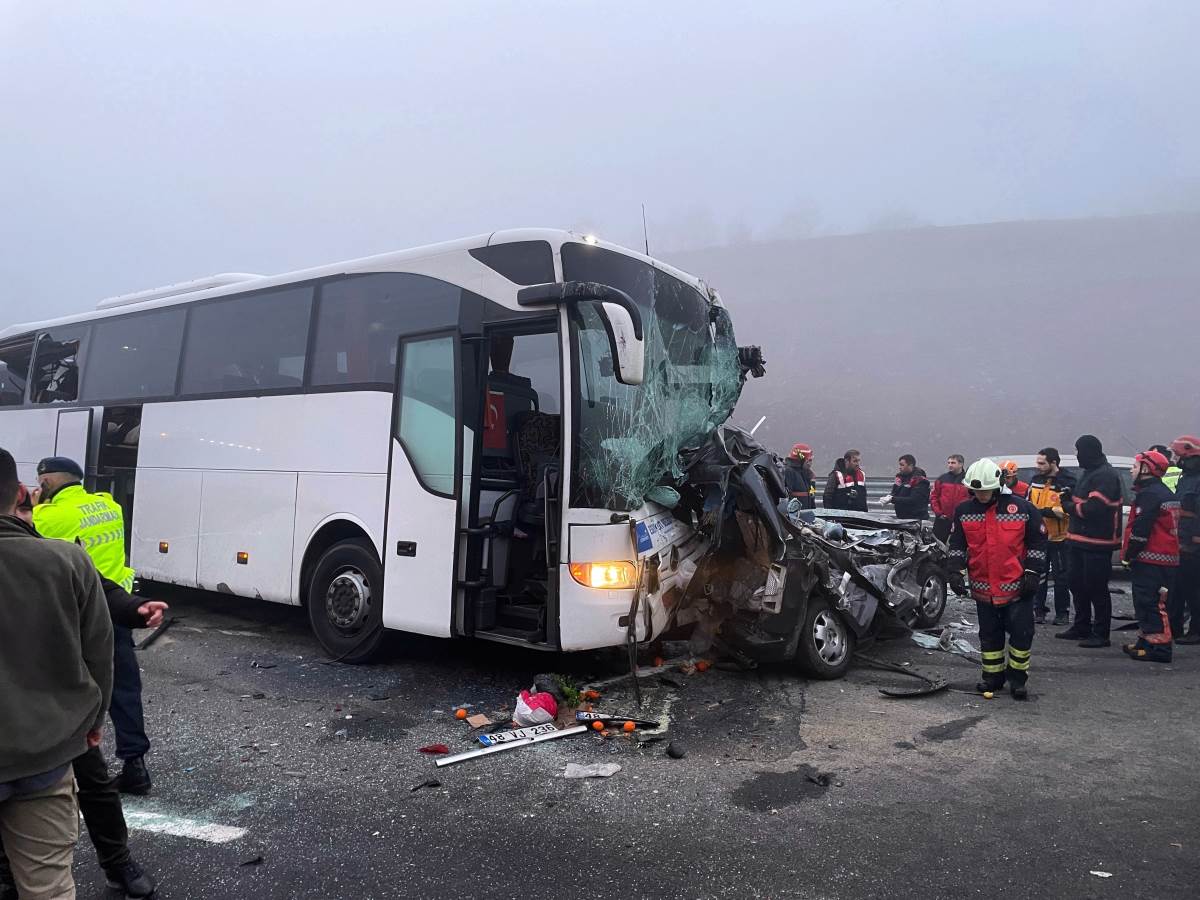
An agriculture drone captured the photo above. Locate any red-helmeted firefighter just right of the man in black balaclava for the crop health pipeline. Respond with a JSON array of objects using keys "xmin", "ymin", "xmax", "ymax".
[{"xmin": 1121, "ymin": 450, "xmax": 1180, "ymax": 662}]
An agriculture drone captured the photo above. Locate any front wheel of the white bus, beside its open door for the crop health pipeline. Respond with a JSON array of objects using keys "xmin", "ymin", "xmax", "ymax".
[{"xmin": 308, "ymin": 538, "xmax": 384, "ymax": 664}]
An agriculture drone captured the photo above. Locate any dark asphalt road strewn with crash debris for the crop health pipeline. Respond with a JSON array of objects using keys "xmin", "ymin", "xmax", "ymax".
[{"xmin": 70, "ymin": 580, "xmax": 1200, "ymax": 900}]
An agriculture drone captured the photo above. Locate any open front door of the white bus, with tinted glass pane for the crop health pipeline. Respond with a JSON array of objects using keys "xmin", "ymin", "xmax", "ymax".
[{"xmin": 383, "ymin": 329, "xmax": 464, "ymax": 636}]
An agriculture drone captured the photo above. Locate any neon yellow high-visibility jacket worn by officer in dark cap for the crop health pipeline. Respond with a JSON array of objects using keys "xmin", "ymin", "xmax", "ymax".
[{"xmin": 34, "ymin": 485, "xmax": 134, "ymax": 590}]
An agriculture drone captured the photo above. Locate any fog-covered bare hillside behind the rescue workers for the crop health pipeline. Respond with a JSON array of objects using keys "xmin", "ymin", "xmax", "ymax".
[{"xmin": 670, "ymin": 215, "xmax": 1200, "ymax": 474}]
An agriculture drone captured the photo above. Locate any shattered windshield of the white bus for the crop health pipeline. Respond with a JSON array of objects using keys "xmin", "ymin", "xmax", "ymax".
[{"xmin": 562, "ymin": 244, "xmax": 742, "ymax": 510}]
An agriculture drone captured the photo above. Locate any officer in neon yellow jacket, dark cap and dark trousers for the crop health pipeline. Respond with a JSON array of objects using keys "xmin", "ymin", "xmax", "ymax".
[{"xmin": 34, "ymin": 456, "xmax": 151, "ymax": 794}]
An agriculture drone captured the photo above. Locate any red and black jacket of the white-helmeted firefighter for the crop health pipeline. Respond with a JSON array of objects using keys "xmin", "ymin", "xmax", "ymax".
[{"xmin": 949, "ymin": 492, "xmax": 1046, "ymax": 606}]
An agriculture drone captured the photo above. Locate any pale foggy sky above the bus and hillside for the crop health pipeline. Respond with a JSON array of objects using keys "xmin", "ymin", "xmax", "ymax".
[{"xmin": 0, "ymin": 0, "xmax": 1200, "ymax": 324}]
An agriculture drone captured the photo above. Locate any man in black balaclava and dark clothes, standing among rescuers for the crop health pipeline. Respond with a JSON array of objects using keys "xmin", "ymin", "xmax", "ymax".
[{"xmin": 1055, "ymin": 434, "xmax": 1121, "ymax": 649}]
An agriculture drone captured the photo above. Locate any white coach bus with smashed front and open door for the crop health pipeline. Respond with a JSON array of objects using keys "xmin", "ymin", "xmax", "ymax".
[{"xmin": 0, "ymin": 229, "xmax": 742, "ymax": 661}]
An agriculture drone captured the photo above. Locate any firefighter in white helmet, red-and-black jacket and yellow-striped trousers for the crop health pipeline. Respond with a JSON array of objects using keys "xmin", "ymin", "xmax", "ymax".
[{"xmin": 949, "ymin": 460, "xmax": 1046, "ymax": 700}]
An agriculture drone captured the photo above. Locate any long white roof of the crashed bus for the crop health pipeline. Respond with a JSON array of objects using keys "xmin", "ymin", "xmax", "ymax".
[{"xmin": 0, "ymin": 228, "xmax": 708, "ymax": 340}]
